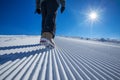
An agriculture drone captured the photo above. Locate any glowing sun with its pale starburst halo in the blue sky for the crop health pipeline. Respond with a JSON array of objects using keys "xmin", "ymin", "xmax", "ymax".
[{"xmin": 81, "ymin": 6, "xmax": 104, "ymax": 26}]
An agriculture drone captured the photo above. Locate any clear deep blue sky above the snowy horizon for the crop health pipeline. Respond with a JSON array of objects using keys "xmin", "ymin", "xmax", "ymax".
[{"xmin": 0, "ymin": 0, "xmax": 120, "ymax": 39}]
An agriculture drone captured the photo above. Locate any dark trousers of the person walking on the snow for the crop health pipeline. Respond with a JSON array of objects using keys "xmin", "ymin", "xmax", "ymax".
[{"xmin": 41, "ymin": 0, "xmax": 59, "ymax": 38}]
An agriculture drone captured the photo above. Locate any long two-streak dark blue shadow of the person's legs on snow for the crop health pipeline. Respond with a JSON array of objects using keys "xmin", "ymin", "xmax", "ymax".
[{"xmin": 0, "ymin": 44, "xmax": 50, "ymax": 65}]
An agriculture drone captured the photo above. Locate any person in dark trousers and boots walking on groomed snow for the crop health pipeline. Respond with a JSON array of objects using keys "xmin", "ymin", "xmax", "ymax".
[{"xmin": 35, "ymin": 0, "xmax": 65, "ymax": 47}]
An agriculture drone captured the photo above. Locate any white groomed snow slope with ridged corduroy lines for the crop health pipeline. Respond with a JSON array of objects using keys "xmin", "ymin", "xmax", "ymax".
[{"xmin": 0, "ymin": 36, "xmax": 120, "ymax": 80}]
